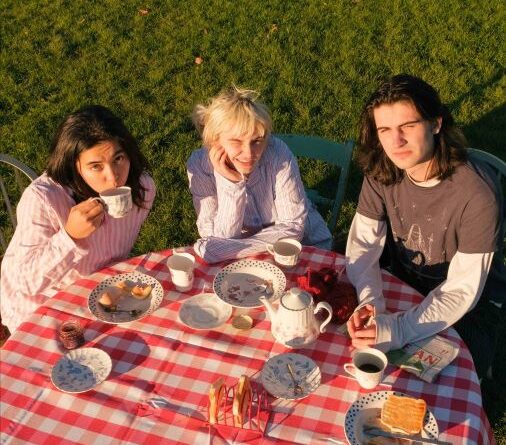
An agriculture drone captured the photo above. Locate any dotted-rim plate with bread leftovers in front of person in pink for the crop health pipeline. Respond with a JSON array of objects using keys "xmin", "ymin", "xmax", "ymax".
[{"xmin": 88, "ymin": 272, "xmax": 163, "ymax": 324}]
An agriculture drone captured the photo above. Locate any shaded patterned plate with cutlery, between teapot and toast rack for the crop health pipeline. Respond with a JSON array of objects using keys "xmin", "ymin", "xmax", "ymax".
[{"xmin": 261, "ymin": 352, "xmax": 322, "ymax": 400}]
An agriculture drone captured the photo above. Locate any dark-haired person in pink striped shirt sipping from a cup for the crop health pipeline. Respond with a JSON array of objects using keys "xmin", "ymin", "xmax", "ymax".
[{"xmin": 0, "ymin": 105, "xmax": 155, "ymax": 332}]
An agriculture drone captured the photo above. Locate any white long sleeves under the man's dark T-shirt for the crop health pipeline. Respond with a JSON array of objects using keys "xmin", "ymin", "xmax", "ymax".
[{"xmin": 346, "ymin": 213, "xmax": 494, "ymax": 351}]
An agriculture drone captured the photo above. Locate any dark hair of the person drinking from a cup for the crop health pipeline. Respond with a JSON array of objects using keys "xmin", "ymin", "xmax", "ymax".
[{"xmin": 46, "ymin": 105, "xmax": 146, "ymax": 207}]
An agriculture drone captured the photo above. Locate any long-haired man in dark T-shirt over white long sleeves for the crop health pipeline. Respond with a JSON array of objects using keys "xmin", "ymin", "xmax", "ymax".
[{"xmin": 346, "ymin": 74, "xmax": 506, "ymax": 377}]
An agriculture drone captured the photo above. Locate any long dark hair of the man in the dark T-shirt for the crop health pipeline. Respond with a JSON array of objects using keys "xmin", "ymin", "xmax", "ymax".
[{"xmin": 358, "ymin": 74, "xmax": 467, "ymax": 185}]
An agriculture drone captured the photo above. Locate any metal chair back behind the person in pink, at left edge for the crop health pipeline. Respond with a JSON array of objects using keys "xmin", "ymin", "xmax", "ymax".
[{"xmin": 0, "ymin": 153, "xmax": 38, "ymax": 254}]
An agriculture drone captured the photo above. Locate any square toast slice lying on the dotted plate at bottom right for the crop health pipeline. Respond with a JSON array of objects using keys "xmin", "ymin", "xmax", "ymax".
[{"xmin": 381, "ymin": 395, "xmax": 427, "ymax": 434}]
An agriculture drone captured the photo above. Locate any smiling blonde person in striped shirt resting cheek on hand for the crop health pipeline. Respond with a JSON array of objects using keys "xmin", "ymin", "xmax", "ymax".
[{"xmin": 187, "ymin": 86, "xmax": 331, "ymax": 263}]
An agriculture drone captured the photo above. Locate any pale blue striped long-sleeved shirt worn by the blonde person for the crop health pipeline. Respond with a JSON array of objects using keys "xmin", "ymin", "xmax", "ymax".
[{"xmin": 187, "ymin": 137, "xmax": 332, "ymax": 263}]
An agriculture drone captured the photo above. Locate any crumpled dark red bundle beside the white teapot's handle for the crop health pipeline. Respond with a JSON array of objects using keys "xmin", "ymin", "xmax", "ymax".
[{"xmin": 297, "ymin": 267, "xmax": 358, "ymax": 324}]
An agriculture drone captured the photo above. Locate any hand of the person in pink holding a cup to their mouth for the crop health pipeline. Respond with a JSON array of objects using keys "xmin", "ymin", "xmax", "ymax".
[{"xmin": 65, "ymin": 198, "xmax": 105, "ymax": 240}]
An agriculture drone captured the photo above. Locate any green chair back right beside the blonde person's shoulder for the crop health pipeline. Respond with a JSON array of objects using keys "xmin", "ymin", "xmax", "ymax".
[{"xmin": 274, "ymin": 134, "xmax": 354, "ymax": 234}]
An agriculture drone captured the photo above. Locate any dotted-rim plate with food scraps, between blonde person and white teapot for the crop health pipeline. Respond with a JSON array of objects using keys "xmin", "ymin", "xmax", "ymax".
[{"xmin": 213, "ymin": 260, "xmax": 286, "ymax": 308}]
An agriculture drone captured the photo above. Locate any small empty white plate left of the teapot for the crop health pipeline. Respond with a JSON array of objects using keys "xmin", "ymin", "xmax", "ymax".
[{"xmin": 179, "ymin": 293, "xmax": 232, "ymax": 329}]
